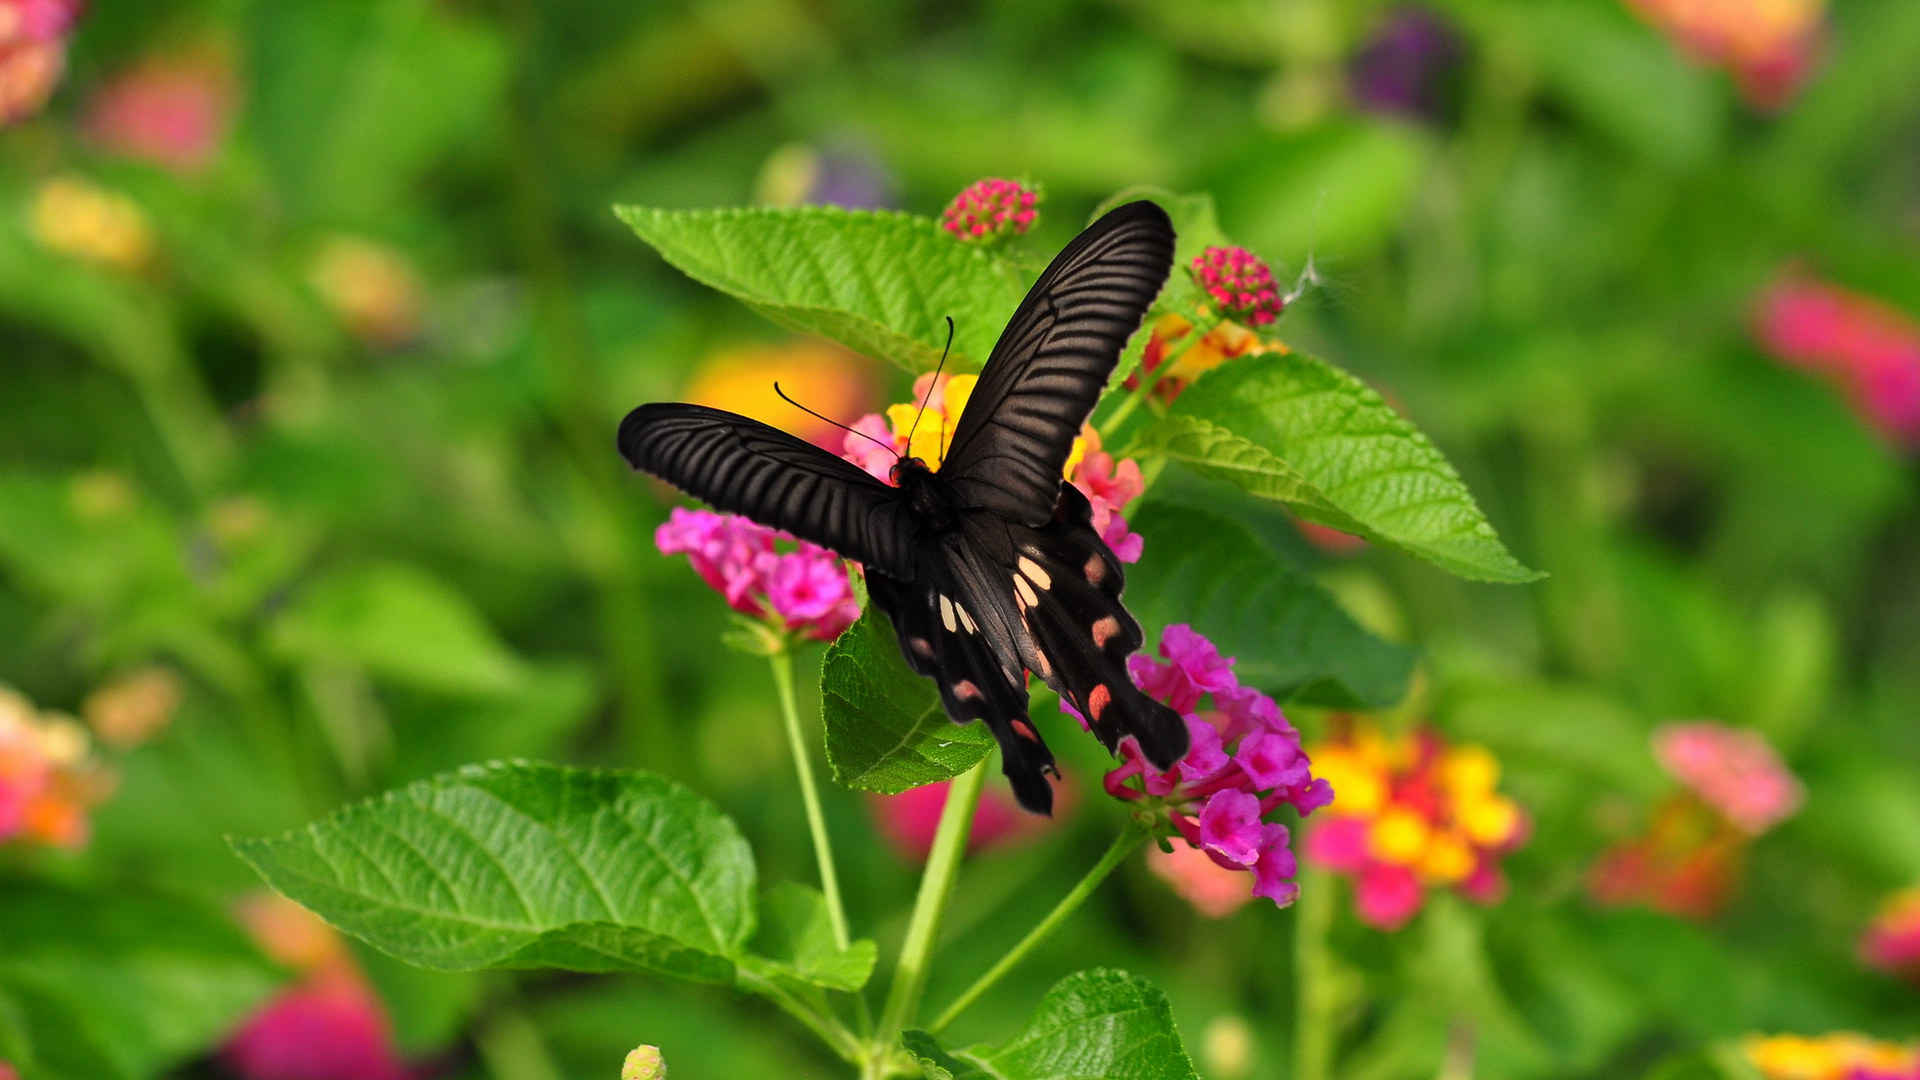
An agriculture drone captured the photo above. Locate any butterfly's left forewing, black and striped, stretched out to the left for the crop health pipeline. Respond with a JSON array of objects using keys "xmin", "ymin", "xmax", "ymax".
[{"xmin": 620, "ymin": 404, "xmax": 914, "ymax": 577}]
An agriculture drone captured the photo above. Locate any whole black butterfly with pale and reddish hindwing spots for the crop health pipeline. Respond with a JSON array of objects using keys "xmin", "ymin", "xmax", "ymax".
[{"xmin": 620, "ymin": 202, "xmax": 1187, "ymax": 813}]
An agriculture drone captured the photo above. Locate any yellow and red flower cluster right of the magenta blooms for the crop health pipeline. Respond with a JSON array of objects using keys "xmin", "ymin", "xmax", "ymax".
[{"xmin": 1306, "ymin": 717, "xmax": 1530, "ymax": 930}]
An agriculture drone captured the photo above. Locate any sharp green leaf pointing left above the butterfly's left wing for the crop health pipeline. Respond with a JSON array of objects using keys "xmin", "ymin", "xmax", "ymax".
[{"xmin": 614, "ymin": 206, "xmax": 1031, "ymax": 371}]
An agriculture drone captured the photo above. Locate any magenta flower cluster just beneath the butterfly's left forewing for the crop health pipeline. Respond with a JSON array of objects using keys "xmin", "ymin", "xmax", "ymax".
[{"xmin": 653, "ymin": 507, "xmax": 860, "ymax": 642}]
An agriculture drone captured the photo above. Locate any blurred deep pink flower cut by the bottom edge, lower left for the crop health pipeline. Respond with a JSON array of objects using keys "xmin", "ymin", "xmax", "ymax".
[{"xmin": 221, "ymin": 970, "xmax": 409, "ymax": 1080}]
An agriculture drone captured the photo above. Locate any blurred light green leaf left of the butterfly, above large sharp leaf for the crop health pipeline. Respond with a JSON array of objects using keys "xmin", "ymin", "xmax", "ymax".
[{"xmin": 269, "ymin": 563, "xmax": 528, "ymax": 694}]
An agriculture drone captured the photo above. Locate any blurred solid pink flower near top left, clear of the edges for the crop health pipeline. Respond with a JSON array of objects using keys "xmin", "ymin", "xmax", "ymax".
[{"xmin": 84, "ymin": 52, "xmax": 234, "ymax": 171}]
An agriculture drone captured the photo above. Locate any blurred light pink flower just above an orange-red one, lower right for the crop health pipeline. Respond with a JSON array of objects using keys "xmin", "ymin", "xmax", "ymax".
[{"xmin": 1653, "ymin": 723, "xmax": 1801, "ymax": 836}]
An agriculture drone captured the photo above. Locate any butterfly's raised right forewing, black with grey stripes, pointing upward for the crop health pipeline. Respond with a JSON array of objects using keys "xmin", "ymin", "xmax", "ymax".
[{"xmin": 941, "ymin": 202, "xmax": 1173, "ymax": 525}]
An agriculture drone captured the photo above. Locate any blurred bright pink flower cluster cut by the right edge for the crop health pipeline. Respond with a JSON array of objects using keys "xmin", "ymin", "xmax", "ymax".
[{"xmin": 1753, "ymin": 273, "xmax": 1920, "ymax": 448}]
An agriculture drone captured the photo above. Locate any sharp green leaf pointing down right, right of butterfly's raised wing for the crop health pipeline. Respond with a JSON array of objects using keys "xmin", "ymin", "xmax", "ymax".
[{"xmin": 1142, "ymin": 354, "xmax": 1542, "ymax": 582}]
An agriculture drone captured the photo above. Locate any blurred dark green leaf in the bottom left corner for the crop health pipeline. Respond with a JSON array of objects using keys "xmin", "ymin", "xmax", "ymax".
[{"xmin": 0, "ymin": 882, "xmax": 278, "ymax": 1080}]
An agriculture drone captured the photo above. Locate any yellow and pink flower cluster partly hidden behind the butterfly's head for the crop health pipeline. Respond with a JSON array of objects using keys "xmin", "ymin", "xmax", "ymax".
[{"xmin": 841, "ymin": 367, "xmax": 1146, "ymax": 563}]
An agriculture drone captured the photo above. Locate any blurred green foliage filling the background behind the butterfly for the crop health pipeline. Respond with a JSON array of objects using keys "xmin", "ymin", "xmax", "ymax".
[{"xmin": 0, "ymin": 0, "xmax": 1920, "ymax": 1080}]
